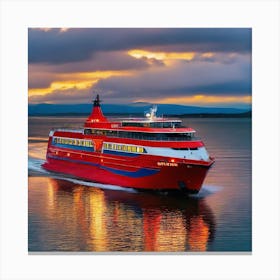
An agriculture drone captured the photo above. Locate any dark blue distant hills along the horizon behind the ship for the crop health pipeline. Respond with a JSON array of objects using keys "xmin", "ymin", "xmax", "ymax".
[{"xmin": 28, "ymin": 102, "xmax": 250, "ymax": 116}]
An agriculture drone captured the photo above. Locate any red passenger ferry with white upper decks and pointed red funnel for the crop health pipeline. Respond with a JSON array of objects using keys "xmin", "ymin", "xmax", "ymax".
[{"xmin": 43, "ymin": 95, "xmax": 214, "ymax": 193}]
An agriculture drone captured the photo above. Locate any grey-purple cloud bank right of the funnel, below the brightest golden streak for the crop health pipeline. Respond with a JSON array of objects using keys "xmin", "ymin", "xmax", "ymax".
[{"xmin": 97, "ymin": 55, "xmax": 252, "ymax": 98}]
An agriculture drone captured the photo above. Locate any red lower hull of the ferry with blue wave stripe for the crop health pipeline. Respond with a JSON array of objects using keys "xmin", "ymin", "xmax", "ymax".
[{"xmin": 43, "ymin": 155, "xmax": 212, "ymax": 193}]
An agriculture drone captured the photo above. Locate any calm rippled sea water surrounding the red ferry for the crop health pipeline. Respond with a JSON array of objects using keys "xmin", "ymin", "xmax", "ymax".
[{"xmin": 28, "ymin": 117, "xmax": 252, "ymax": 252}]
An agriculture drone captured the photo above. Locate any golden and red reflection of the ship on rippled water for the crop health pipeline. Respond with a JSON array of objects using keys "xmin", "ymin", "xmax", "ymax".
[{"xmin": 29, "ymin": 177, "xmax": 215, "ymax": 252}]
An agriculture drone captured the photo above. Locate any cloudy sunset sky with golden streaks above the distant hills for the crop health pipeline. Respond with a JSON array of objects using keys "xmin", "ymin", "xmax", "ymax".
[{"xmin": 28, "ymin": 28, "xmax": 252, "ymax": 108}]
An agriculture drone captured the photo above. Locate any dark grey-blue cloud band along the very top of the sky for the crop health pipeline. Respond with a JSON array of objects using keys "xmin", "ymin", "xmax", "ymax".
[{"xmin": 28, "ymin": 28, "xmax": 251, "ymax": 64}]
